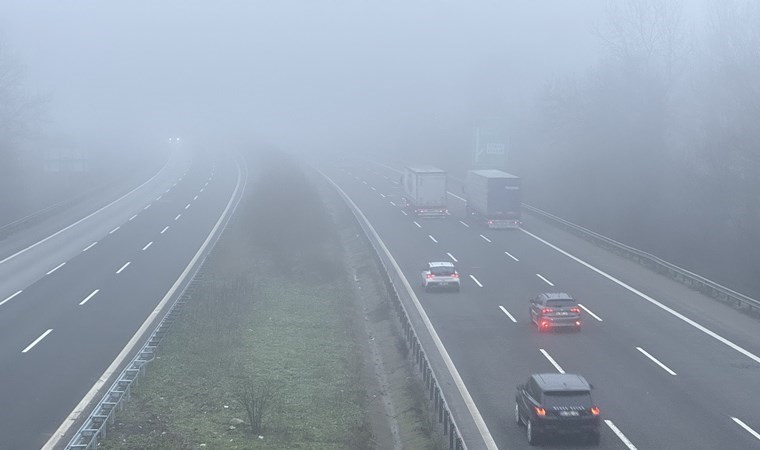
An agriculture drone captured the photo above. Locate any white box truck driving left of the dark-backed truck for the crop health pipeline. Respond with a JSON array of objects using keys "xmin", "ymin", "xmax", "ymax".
[{"xmin": 401, "ymin": 166, "xmax": 449, "ymax": 218}]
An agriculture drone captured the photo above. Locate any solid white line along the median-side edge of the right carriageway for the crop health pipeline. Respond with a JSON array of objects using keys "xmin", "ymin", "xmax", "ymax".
[{"xmin": 320, "ymin": 172, "xmax": 498, "ymax": 450}]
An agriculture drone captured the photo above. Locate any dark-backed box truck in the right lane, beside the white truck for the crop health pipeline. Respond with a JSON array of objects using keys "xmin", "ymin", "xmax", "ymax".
[{"xmin": 464, "ymin": 169, "xmax": 522, "ymax": 228}]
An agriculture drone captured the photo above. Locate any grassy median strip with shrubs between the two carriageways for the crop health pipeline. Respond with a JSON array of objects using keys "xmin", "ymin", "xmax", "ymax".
[{"xmin": 100, "ymin": 152, "xmax": 435, "ymax": 450}]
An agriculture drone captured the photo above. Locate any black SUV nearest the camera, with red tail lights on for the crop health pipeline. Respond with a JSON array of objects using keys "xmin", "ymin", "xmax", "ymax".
[{"xmin": 515, "ymin": 373, "xmax": 600, "ymax": 445}]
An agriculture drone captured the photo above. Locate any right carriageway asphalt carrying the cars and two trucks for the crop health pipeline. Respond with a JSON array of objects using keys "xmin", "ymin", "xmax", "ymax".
[{"xmin": 323, "ymin": 160, "xmax": 760, "ymax": 449}]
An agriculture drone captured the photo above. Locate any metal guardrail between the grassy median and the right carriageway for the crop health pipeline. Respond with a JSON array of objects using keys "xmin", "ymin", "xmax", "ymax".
[{"xmin": 323, "ymin": 175, "xmax": 467, "ymax": 450}]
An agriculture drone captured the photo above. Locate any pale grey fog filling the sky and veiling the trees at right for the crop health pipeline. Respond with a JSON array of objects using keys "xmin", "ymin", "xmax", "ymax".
[{"xmin": 0, "ymin": 0, "xmax": 760, "ymax": 294}]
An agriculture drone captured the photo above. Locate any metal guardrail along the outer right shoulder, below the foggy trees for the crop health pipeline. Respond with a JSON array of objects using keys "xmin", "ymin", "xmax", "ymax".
[{"xmin": 522, "ymin": 203, "xmax": 760, "ymax": 315}]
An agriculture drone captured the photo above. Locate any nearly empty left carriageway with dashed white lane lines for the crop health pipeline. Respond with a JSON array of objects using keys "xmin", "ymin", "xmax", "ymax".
[{"xmin": 0, "ymin": 150, "xmax": 244, "ymax": 450}]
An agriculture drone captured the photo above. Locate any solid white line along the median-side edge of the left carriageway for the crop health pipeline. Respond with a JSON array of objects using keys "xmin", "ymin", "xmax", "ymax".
[{"xmin": 42, "ymin": 156, "xmax": 245, "ymax": 450}]
